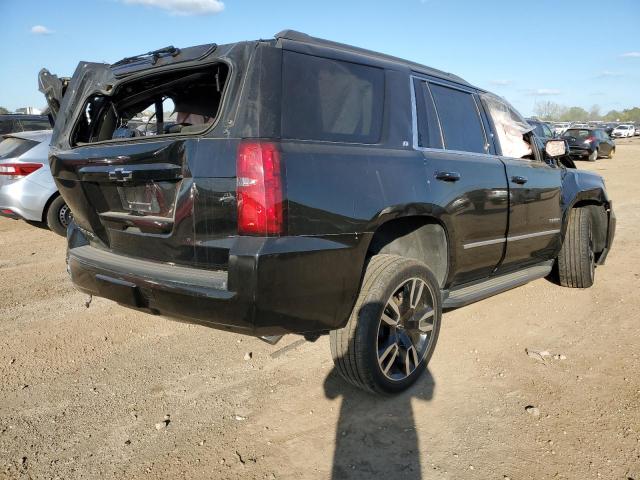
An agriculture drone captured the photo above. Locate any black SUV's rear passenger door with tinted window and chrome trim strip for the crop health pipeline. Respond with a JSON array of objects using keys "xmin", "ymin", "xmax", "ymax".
[{"xmin": 413, "ymin": 78, "xmax": 508, "ymax": 286}]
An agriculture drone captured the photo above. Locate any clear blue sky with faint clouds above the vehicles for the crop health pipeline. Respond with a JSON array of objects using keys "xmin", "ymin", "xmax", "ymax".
[{"xmin": 0, "ymin": 0, "xmax": 640, "ymax": 115}]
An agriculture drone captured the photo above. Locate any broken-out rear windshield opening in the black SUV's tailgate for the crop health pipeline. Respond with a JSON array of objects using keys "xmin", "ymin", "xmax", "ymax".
[{"xmin": 71, "ymin": 64, "xmax": 229, "ymax": 145}]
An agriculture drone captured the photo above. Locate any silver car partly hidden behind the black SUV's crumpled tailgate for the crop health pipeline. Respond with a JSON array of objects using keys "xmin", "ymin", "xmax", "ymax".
[{"xmin": 0, "ymin": 130, "xmax": 71, "ymax": 236}]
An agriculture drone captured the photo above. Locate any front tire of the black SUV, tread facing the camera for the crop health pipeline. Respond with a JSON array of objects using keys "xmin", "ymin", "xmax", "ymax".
[{"xmin": 557, "ymin": 208, "xmax": 596, "ymax": 288}]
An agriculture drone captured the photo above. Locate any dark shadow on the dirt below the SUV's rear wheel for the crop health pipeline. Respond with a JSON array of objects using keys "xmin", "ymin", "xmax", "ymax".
[{"xmin": 324, "ymin": 368, "xmax": 435, "ymax": 480}]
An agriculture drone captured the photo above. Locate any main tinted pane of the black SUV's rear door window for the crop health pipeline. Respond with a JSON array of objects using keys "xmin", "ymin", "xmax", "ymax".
[{"xmin": 430, "ymin": 84, "xmax": 486, "ymax": 153}]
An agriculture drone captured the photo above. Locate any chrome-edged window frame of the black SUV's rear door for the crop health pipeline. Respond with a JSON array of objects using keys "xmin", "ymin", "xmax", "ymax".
[{"xmin": 409, "ymin": 73, "xmax": 497, "ymax": 158}]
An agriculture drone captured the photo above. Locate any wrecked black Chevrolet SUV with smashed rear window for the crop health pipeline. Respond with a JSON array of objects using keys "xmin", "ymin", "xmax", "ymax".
[{"xmin": 40, "ymin": 31, "xmax": 615, "ymax": 393}]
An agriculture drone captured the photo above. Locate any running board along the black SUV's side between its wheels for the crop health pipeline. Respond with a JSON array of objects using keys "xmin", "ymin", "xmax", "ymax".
[{"xmin": 442, "ymin": 260, "xmax": 553, "ymax": 308}]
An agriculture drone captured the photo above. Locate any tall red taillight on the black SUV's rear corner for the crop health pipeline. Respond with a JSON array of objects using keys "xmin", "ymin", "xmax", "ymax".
[{"xmin": 236, "ymin": 141, "xmax": 284, "ymax": 236}]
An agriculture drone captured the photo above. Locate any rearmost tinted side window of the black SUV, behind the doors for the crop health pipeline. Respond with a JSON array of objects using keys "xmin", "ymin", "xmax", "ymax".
[{"xmin": 282, "ymin": 51, "xmax": 384, "ymax": 143}]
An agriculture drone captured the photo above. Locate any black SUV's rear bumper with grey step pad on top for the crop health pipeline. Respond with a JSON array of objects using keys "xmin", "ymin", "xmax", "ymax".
[{"xmin": 67, "ymin": 224, "xmax": 368, "ymax": 336}]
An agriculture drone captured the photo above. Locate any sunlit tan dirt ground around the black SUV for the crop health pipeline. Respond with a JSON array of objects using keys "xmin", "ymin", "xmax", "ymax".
[{"xmin": 0, "ymin": 138, "xmax": 640, "ymax": 480}]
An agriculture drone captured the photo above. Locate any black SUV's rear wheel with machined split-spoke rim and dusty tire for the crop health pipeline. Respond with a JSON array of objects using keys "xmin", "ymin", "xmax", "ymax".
[{"xmin": 330, "ymin": 255, "xmax": 442, "ymax": 394}]
